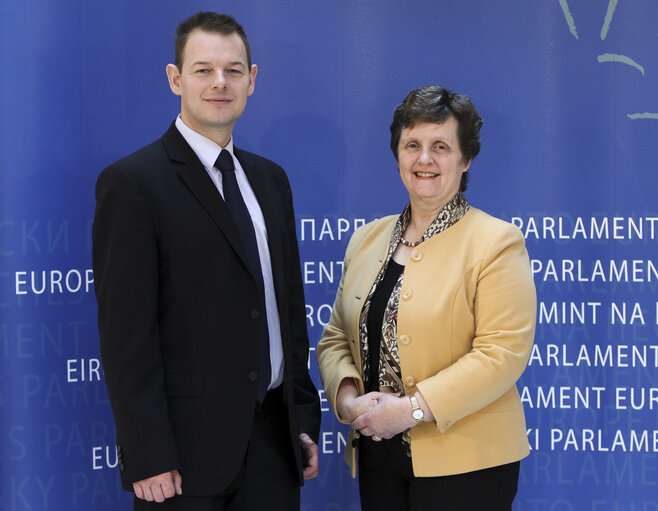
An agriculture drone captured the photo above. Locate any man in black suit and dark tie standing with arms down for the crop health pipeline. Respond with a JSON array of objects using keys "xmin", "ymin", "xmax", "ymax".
[{"xmin": 93, "ymin": 12, "xmax": 320, "ymax": 511}]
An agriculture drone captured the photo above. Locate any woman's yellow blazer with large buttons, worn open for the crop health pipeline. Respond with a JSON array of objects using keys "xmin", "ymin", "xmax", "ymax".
[{"xmin": 317, "ymin": 207, "xmax": 537, "ymax": 477}]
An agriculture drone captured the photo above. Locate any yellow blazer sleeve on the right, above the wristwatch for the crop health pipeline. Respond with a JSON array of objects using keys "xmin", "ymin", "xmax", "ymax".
[{"xmin": 417, "ymin": 225, "xmax": 537, "ymax": 432}]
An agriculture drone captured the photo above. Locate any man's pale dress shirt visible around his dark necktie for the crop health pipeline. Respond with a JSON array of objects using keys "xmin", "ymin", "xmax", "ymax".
[{"xmin": 176, "ymin": 115, "xmax": 283, "ymax": 389}]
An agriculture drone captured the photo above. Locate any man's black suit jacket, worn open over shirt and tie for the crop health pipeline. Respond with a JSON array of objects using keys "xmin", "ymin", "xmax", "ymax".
[{"xmin": 93, "ymin": 124, "xmax": 320, "ymax": 495}]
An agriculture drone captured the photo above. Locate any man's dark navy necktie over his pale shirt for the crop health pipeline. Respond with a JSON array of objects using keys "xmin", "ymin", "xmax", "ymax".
[{"xmin": 215, "ymin": 149, "xmax": 272, "ymax": 403}]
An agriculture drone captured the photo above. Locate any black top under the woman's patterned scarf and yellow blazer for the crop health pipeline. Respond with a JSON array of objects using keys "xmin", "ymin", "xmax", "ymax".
[{"xmin": 366, "ymin": 258, "xmax": 404, "ymax": 392}]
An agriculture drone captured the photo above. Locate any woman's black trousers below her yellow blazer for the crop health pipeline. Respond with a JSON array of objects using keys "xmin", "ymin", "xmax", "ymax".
[{"xmin": 359, "ymin": 435, "xmax": 520, "ymax": 511}]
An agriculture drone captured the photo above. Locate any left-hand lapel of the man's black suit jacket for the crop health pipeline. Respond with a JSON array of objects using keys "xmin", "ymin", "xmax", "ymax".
[{"xmin": 162, "ymin": 124, "xmax": 249, "ymax": 269}]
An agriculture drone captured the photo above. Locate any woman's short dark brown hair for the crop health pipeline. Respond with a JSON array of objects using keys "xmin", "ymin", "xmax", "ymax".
[{"xmin": 391, "ymin": 85, "xmax": 482, "ymax": 192}]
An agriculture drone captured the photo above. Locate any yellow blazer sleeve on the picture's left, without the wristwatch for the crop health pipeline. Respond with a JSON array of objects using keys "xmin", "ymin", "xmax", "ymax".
[{"xmin": 316, "ymin": 228, "xmax": 365, "ymax": 424}]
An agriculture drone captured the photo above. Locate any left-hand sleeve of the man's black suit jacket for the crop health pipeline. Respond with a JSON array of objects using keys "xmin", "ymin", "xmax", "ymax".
[{"xmin": 92, "ymin": 164, "xmax": 179, "ymax": 489}]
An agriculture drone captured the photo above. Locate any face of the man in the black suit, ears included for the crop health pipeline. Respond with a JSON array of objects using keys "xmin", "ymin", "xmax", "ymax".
[{"xmin": 167, "ymin": 30, "xmax": 258, "ymax": 146}]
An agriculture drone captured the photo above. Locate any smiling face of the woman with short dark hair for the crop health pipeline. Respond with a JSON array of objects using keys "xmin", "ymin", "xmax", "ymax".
[{"xmin": 398, "ymin": 117, "xmax": 471, "ymax": 210}]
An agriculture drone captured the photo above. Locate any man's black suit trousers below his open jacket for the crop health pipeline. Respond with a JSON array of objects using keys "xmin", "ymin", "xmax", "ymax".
[{"xmin": 133, "ymin": 389, "xmax": 300, "ymax": 511}]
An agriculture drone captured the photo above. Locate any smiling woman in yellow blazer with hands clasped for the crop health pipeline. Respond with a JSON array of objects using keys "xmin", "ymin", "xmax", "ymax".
[{"xmin": 317, "ymin": 85, "xmax": 536, "ymax": 511}]
